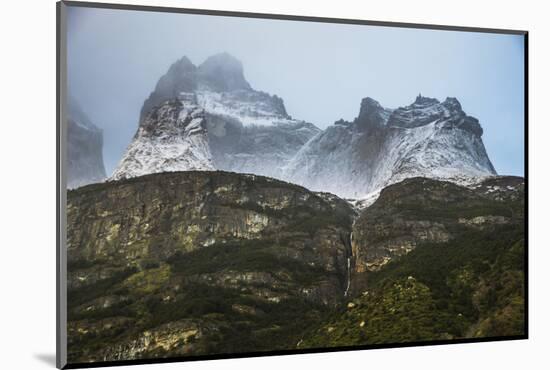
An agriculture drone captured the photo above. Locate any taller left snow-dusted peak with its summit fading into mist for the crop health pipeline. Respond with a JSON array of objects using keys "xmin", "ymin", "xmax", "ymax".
[{"xmin": 117, "ymin": 53, "xmax": 320, "ymax": 183}]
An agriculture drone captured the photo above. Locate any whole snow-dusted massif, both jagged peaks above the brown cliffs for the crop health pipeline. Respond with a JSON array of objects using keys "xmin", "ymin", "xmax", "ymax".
[{"xmin": 112, "ymin": 53, "xmax": 496, "ymax": 199}]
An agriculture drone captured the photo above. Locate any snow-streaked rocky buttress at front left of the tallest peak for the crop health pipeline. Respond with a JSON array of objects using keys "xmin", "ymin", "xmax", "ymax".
[{"xmin": 111, "ymin": 93, "xmax": 214, "ymax": 180}]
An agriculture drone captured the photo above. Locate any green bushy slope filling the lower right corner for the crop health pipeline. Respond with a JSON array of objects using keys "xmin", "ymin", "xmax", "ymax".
[{"xmin": 301, "ymin": 226, "xmax": 524, "ymax": 347}]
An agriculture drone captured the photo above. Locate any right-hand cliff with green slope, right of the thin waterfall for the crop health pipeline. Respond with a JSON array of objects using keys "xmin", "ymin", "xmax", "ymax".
[{"xmin": 299, "ymin": 177, "xmax": 526, "ymax": 348}]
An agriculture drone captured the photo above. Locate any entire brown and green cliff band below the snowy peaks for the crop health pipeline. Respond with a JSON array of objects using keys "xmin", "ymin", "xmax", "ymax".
[{"xmin": 68, "ymin": 171, "xmax": 525, "ymax": 362}]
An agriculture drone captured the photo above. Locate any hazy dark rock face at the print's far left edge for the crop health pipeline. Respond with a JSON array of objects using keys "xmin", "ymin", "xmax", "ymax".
[{"xmin": 67, "ymin": 97, "xmax": 105, "ymax": 189}]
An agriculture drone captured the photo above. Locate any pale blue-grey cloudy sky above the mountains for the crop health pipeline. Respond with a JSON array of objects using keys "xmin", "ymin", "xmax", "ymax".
[{"xmin": 67, "ymin": 7, "xmax": 525, "ymax": 176}]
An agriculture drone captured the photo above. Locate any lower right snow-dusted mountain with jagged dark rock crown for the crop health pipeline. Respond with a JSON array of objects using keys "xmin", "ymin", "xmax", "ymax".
[{"xmin": 284, "ymin": 96, "xmax": 496, "ymax": 198}]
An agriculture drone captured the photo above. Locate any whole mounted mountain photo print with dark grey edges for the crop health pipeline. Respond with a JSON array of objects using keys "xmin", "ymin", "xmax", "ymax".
[{"xmin": 57, "ymin": 2, "xmax": 527, "ymax": 367}]
